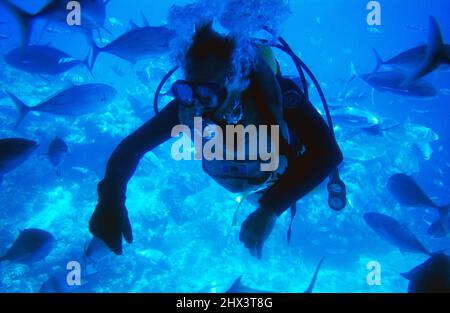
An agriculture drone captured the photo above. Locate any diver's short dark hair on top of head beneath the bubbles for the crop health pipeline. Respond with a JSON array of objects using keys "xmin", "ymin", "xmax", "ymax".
[{"xmin": 186, "ymin": 22, "xmax": 236, "ymax": 70}]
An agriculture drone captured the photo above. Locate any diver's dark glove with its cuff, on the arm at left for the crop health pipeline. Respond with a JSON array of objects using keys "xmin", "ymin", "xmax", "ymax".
[{"xmin": 89, "ymin": 180, "xmax": 133, "ymax": 255}]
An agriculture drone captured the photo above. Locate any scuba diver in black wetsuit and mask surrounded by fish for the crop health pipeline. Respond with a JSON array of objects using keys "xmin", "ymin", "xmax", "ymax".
[{"xmin": 89, "ymin": 23, "xmax": 346, "ymax": 259}]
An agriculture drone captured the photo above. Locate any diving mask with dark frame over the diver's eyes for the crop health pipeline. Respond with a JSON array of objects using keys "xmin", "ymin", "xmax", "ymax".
[{"xmin": 172, "ymin": 80, "xmax": 228, "ymax": 112}]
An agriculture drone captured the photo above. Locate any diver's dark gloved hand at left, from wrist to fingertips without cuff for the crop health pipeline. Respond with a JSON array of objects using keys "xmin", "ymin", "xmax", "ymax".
[{"xmin": 89, "ymin": 202, "xmax": 133, "ymax": 255}]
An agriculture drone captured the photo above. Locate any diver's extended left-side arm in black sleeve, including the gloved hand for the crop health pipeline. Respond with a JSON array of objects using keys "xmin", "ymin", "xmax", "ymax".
[{"xmin": 89, "ymin": 102, "xmax": 178, "ymax": 255}]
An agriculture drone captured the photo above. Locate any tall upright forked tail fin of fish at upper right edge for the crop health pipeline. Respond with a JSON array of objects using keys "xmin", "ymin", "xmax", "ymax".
[{"xmin": 402, "ymin": 16, "xmax": 447, "ymax": 86}]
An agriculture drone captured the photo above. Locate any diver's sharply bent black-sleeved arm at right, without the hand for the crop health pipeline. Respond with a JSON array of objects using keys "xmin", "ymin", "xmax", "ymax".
[{"xmin": 259, "ymin": 91, "xmax": 343, "ymax": 215}]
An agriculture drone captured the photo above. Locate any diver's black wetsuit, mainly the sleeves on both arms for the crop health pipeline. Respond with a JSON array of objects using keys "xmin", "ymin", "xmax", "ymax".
[{"xmin": 99, "ymin": 73, "xmax": 343, "ymax": 215}]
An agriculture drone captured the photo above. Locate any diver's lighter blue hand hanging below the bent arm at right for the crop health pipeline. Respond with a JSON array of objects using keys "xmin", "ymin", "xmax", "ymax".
[{"xmin": 239, "ymin": 207, "xmax": 277, "ymax": 259}]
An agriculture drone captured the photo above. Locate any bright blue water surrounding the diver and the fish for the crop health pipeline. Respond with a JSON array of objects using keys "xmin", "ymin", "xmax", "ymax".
[{"xmin": 0, "ymin": 0, "xmax": 450, "ymax": 292}]
